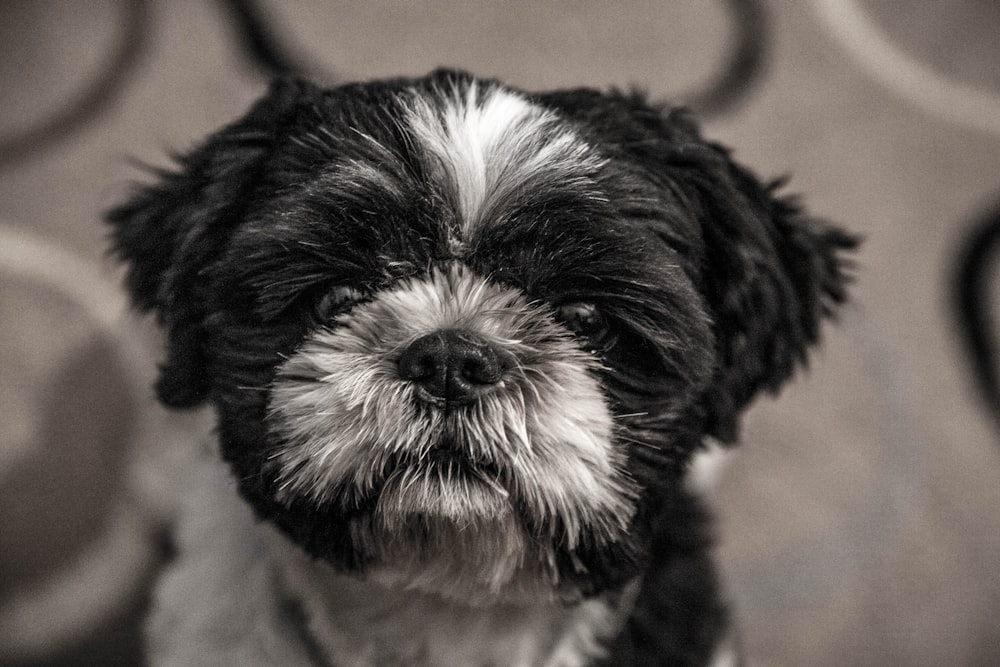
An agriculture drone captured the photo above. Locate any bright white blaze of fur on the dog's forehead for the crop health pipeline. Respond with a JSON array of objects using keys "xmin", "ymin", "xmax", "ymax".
[{"xmin": 405, "ymin": 81, "xmax": 604, "ymax": 240}]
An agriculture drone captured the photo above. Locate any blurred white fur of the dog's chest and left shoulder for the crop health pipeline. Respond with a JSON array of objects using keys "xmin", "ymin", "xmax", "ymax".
[{"xmin": 149, "ymin": 438, "xmax": 634, "ymax": 667}]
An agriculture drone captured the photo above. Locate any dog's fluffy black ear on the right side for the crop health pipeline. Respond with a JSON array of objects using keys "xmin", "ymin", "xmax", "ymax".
[{"xmin": 538, "ymin": 89, "xmax": 857, "ymax": 442}]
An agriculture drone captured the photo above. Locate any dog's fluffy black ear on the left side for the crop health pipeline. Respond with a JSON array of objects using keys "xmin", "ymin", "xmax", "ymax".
[{"xmin": 107, "ymin": 75, "xmax": 316, "ymax": 407}]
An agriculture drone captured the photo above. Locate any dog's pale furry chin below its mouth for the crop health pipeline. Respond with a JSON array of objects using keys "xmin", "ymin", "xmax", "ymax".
[{"xmin": 270, "ymin": 452, "xmax": 612, "ymax": 606}]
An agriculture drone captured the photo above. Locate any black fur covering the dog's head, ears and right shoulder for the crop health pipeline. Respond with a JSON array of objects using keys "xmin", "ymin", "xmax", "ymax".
[{"xmin": 108, "ymin": 71, "xmax": 854, "ymax": 664}]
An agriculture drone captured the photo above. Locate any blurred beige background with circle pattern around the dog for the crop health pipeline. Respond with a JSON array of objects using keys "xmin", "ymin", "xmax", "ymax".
[{"xmin": 0, "ymin": 0, "xmax": 1000, "ymax": 667}]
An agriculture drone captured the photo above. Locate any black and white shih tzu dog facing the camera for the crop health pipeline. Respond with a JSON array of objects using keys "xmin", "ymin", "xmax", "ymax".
[{"xmin": 109, "ymin": 70, "xmax": 854, "ymax": 665}]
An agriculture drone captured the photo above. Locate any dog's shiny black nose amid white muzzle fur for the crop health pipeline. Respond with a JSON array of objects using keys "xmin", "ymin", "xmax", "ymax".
[{"xmin": 397, "ymin": 329, "xmax": 507, "ymax": 406}]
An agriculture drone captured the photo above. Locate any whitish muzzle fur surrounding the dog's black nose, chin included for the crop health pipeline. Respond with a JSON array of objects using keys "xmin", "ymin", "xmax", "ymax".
[{"xmin": 269, "ymin": 264, "xmax": 635, "ymax": 594}]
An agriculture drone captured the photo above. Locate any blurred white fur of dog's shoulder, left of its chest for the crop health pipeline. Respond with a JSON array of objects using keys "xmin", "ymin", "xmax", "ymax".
[{"xmin": 146, "ymin": 434, "xmax": 318, "ymax": 667}]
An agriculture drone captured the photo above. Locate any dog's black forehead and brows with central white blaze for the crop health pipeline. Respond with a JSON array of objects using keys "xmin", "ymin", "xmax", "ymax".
[{"xmin": 216, "ymin": 72, "xmax": 712, "ymax": 324}]
